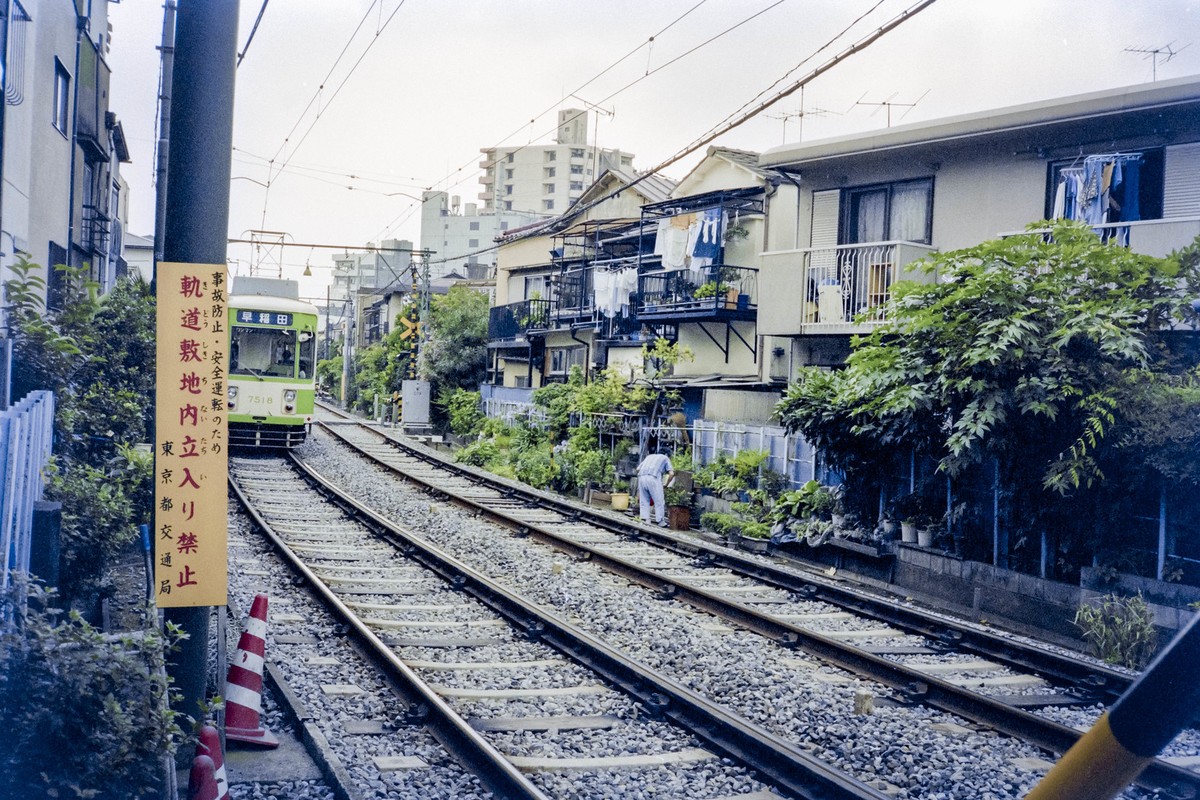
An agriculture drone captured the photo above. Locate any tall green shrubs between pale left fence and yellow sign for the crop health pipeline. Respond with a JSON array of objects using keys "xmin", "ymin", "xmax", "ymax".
[{"xmin": 5, "ymin": 259, "xmax": 155, "ymax": 614}]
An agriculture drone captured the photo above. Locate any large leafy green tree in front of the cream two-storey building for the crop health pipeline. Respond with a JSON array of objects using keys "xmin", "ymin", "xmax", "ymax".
[{"xmin": 779, "ymin": 223, "xmax": 1200, "ymax": 573}]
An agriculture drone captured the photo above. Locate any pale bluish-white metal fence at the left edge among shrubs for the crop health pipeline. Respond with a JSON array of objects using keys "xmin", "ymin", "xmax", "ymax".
[{"xmin": 0, "ymin": 391, "xmax": 54, "ymax": 622}]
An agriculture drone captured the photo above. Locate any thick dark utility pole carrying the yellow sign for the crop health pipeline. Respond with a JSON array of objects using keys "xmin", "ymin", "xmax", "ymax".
[{"xmin": 158, "ymin": 0, "xmax": 238, "ymax": 753}]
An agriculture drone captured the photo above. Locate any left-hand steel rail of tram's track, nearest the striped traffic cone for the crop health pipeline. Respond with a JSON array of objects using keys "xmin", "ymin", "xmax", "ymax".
[{"xmin": 229, "ymin": 475, "xmax": 550, "ymax": 800}]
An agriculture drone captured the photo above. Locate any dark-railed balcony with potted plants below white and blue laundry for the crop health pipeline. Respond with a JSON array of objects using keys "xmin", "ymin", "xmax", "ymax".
[{"xmin": 637, "ymin": 265, "xmax": 758, "ymax": 323}]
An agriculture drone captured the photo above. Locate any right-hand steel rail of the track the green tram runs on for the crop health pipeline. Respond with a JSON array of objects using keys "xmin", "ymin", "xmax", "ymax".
[{"xmin": 288, "ymin": 452, "xmax": 887, "ymax": 800}]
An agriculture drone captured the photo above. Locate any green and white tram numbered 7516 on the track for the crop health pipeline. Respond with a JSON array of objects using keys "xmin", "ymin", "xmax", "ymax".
[{"xmin": 229, "ymin": 295, "xmax": 317, "ymax": 447}]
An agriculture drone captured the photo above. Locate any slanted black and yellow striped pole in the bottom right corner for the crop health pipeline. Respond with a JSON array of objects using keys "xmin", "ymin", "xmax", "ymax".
[{"xmin": 1026, "ymin": 615, "xmax": 1200, "ymax": 800}]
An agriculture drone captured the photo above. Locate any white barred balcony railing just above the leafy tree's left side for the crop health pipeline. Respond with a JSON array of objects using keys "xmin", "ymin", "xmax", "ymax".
[{"xmin": 802, "ymin": 241, "xmax": 934, "ymax": 329}]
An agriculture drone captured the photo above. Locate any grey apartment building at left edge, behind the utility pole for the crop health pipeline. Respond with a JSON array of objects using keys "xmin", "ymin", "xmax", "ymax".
[{"xmin": 0, "ymin": 0, "xmax": 130, "ymax": 306}]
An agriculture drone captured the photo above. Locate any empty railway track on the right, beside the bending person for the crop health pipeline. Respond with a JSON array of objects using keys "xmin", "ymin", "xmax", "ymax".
[{"xmin": 292, "ymin": 410, "xmax": 1196, "ymax": 790}]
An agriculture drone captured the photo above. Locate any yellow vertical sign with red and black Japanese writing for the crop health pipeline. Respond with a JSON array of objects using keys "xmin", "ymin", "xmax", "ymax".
[{"xmin": 154, "ymin": 263, "xmax": 229, "ymax": 607}]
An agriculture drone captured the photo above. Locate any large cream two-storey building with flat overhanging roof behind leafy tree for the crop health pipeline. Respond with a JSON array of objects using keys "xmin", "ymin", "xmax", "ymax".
[{"xmin": 758, "ymin": 78, "xmax": 1200, "ymax": 372}]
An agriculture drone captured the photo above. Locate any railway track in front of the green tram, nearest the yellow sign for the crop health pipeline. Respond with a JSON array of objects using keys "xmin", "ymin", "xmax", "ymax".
[{"xmin": 230, "ymin": 458, "xmax": 884, "ymax": 799}]
